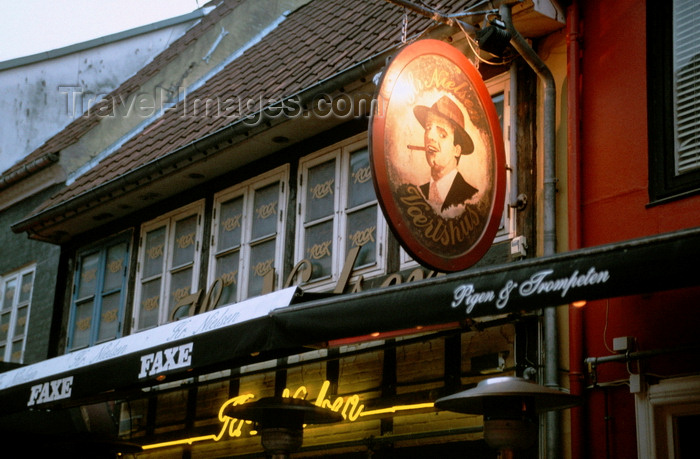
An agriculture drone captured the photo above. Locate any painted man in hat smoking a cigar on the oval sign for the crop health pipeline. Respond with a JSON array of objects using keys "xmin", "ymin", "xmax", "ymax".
[{"xmin": 413, "ymin": 96, "xmax": 478, "ymax": 215}]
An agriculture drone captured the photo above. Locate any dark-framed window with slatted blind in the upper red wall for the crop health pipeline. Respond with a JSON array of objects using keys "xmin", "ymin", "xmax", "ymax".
[{"xmin": 647, "ymin": 0, "xmax": 700, "ymax": 202}]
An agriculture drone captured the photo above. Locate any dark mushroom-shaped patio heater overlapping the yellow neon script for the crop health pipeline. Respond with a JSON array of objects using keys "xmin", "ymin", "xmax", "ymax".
[{"xmin": 224, "ymin": 397, "xmax": 343, "ymax": 459}]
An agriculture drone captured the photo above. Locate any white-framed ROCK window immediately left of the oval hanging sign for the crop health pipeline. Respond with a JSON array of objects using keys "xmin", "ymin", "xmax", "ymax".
[{"xmin": 295, "ymin": 135, "xmax": 386, "ymax": 289}]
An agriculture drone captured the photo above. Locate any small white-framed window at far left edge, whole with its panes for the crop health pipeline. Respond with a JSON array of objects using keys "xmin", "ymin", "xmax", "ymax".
[{"xmin": 0, "ymin": 266, "xmax": 34, "ymax": 363}]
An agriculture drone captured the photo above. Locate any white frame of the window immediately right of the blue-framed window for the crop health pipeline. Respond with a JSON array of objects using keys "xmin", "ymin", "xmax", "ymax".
[{"xmin": 131, "ymin": 199, "xmax": 204, "ymax": 332}]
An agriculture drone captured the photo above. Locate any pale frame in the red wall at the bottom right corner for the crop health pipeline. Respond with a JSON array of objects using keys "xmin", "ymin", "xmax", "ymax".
[{"xmin": 635, "ymin": 375, "xmax": 700, "ymax": 459}]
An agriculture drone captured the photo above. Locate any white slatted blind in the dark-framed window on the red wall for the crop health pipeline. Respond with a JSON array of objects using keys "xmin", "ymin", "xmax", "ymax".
[{"xmin": 673, "ymin": 0, "xmax": 700, "ymax": 174}]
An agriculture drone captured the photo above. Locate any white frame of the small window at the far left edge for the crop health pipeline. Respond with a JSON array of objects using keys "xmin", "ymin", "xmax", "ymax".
[{"xmin": 0, "ymin": 265, "xmax": 36, "ymax": 363}]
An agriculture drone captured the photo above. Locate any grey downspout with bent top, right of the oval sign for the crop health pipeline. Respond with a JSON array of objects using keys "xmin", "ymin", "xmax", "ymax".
[{"xmin": 499, "ymin": 3, "xmax": 561, "ymax": 459}]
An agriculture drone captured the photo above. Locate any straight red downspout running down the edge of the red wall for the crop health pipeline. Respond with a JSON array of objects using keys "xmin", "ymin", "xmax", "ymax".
[{"xmin": 566, "ymin": 0, "xmax": 585, "ymax": 459}]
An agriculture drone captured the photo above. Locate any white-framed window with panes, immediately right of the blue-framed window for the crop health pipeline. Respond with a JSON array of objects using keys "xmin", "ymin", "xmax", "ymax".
[{"xmin": 133, "ymin": 201, "xmax": 204, "ymax": 331}]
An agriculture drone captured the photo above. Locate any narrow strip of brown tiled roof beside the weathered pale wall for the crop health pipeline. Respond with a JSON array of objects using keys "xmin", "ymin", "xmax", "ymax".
[{"xmin": 2, "ymin": 0, "xmax": 242, "ymax": 182}]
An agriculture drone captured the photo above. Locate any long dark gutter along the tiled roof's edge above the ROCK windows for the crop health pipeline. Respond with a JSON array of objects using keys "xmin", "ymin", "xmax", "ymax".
[{"xmin": 11, "ymin": 25, "xmax": 455, "ymax": 237}]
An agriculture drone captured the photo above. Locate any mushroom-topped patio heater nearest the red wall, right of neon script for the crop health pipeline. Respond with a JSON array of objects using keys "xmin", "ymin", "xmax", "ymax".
[{"xmin": 435, "ymin": 376, "xmax": 580, "ymax": 457}]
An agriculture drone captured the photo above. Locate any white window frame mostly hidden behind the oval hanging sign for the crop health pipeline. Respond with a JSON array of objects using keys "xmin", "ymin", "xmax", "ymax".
[{"xmin": 399, "ymin": 66, "xmax": 518, "ymax": 270}]
